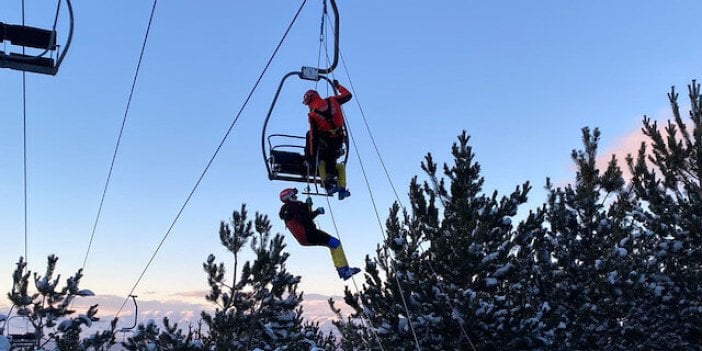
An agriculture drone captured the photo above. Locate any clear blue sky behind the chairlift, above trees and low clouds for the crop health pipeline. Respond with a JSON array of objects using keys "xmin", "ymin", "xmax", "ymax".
[{"xmin": 0, "ymin": 0, "xmax": 702, "ymax": 328}]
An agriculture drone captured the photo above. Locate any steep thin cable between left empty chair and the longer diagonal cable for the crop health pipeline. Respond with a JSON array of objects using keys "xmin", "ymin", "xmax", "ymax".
[{"xmin": 81, "ymin": 0, "xmax": 158, "ymax": 269}]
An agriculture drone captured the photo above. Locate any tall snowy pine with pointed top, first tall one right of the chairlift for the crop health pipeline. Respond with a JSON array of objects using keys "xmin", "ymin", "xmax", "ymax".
[{"xmin": 422, "ymin": 132, "xmax": 542, "ymax": 350}]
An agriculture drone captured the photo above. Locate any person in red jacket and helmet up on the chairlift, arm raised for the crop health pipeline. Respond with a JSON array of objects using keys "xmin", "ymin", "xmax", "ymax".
[{"xmin": 302, "ymin": 79, "xmax": 351, "ymax": 200}]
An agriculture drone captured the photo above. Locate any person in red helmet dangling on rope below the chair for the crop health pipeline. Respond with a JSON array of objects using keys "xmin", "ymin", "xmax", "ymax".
[{"xmin": 279, "ymin": 188, "xmax": 361, "ymax": 280}]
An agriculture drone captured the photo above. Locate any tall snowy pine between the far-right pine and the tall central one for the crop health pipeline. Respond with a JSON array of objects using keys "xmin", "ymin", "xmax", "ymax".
[{"xmin": 534, "ymin": 128, "xmax": 638, "ymax": 350}]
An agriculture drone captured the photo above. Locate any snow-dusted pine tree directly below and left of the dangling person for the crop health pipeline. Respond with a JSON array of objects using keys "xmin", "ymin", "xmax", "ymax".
[{"xmin": 202, "ymin": 205, "xmax": 325, "ymax": 350}]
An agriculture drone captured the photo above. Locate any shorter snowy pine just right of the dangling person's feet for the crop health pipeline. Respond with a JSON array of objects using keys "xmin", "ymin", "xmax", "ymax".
[{"xmin": 332, "ymin": 184, "xmax": 446, "ymax": 350}]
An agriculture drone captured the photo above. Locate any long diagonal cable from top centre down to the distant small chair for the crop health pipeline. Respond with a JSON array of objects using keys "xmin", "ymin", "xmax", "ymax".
[{"xmin": 115, "ymin": 0, "xmax": 307, "ymax": 318}]
